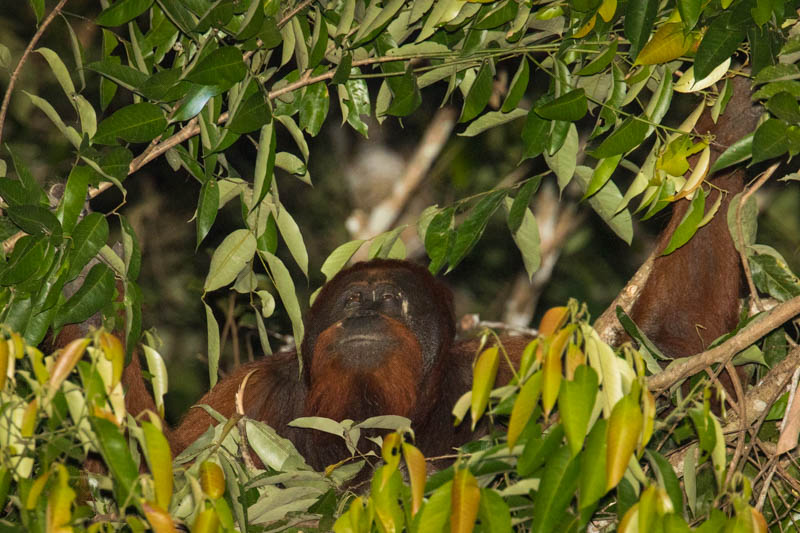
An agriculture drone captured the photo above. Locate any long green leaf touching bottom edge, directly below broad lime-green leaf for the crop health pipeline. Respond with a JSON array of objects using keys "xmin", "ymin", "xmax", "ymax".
[{"xmin": 531, "ymin": 446, "xmax": 580, "ymax": 533}]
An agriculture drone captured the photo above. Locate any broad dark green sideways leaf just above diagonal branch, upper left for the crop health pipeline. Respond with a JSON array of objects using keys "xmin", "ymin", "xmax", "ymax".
[{"xmin": 93, "ymin": 102, "xmax": 167, "ymax": 144}]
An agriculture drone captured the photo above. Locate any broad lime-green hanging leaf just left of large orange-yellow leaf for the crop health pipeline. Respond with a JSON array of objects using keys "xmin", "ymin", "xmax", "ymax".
[{"xmin": 558, "ymin": 365, "xmax": 598, "ymax": 457}]
